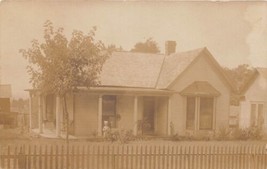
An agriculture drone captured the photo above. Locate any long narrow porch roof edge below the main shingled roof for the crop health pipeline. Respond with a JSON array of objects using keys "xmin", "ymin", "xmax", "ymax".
[{"xmin": 78, "ymin": 86, "xmax": 176, "ymax": 96}]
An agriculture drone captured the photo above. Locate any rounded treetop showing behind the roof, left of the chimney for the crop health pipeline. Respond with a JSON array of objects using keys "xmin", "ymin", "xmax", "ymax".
[{"xmin": 131, "ymin": 38, "xmax": 160, "ymax": 53}]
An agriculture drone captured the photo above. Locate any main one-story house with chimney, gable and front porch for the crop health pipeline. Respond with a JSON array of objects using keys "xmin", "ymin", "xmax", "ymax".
[{"xmin": 29, "ymin": 41, "xmax": 232, "ymax": 136}]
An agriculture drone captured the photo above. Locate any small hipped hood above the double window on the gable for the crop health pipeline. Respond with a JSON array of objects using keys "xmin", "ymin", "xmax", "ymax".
[{"xmin": 180, "ymin": 81, "xmax": 220, "ymax": 96}]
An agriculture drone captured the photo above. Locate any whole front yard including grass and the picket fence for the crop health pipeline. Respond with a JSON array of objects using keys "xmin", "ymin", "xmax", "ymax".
[{"xmin": 0, "ymin": 129, "xmax": 267, "ymax": 169}]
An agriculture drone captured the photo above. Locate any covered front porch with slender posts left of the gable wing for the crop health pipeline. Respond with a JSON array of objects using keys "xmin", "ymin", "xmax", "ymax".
[{"xmin": 30, "ymin": 87, "xmax": 175, "ymax": 137}]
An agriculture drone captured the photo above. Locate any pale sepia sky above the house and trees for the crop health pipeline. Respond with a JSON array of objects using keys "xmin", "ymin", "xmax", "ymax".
[{"xmin": 0, "ymin": 0, "xmax": 267, "ymax": 98}]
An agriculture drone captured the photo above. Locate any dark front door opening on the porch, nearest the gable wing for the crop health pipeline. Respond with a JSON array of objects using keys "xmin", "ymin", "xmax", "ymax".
[{"xmin": 143, "ymin": 97, "xmax": 155, "ymax": 134}]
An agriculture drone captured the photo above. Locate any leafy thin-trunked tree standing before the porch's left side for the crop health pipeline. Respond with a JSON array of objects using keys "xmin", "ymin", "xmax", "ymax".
[{"xmin": 20, "ymin": 21, "xmax": 109, "ymax": 143}]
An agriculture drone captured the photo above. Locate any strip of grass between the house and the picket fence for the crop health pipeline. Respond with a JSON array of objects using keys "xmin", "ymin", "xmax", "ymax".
[{"xmin": 0, "ymin": 129, "xmax": 266, "ymax": 147}]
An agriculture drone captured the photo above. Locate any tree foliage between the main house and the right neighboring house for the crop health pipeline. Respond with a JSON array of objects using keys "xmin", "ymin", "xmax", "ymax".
[{"xmin": 224, "ymin": 64, "xmax": 255, "ymax": 93}]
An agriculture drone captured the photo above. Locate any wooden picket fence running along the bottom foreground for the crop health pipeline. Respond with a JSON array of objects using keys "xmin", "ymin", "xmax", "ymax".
[{"xmin": 0, "ymin": 144, "xmax": 267, "ymax": 169}]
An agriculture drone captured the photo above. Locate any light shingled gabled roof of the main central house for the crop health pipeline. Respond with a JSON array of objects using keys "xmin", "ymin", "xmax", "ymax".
[{"xmin": 100, "ymin": 48, "xmax": 231, "ymax": 89}]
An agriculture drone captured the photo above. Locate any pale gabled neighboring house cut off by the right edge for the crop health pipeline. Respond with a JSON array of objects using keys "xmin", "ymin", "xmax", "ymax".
[{"xmin": 239, "ymin": 68, "xmax": 267, "ymax": 133}]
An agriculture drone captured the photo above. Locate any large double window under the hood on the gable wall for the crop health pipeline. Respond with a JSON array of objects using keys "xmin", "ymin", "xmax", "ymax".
[{"xmin": 186, "ymin": 97, "xmax": 214, "ymax": 130}]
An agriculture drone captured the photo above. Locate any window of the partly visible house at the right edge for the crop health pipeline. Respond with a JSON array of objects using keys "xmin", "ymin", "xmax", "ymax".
[{"xmin": 250, "ymin": 103, "xmax": 264, "ymax": 127}]
